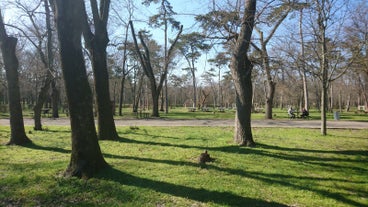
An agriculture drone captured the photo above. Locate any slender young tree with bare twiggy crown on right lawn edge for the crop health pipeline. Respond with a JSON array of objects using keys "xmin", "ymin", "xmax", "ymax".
[{"xmin": 311, "ymin": 0, "xmax": 351, "ymax": 135}]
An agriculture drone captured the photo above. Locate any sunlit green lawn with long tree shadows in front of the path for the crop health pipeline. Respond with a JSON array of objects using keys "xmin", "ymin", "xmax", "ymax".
[{"xmin": 0, "ymin": 126, "xmax": 368, "ymax": 207}]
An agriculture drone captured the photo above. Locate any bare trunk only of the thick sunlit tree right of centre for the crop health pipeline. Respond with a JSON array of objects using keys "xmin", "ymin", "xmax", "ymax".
[{"xmin": 230, "ymin": 0, "xmax": 256, "ymax": 146}]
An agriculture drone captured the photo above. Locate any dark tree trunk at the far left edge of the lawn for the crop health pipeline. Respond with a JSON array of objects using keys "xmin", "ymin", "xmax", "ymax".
[{"xmin": 0, "ymin": 10, "xmax": 31, "ymax": 145}]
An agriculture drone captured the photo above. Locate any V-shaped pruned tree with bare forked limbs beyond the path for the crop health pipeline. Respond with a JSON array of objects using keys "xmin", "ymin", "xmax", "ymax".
[{"xmin": 129, "ymin": 21, "xmax": 183, "ymax": 117}]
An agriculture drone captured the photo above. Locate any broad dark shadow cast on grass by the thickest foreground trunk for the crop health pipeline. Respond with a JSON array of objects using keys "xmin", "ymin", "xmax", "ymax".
[{"xmin": 97, "ymin": 167, "xmax": 287, "ymax": 207}]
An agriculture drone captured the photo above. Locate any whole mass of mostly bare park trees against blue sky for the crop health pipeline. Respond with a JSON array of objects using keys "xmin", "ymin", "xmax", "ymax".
[{"xmin": 0, "ymin": 0, "xmax": 368, "ymax": 177}]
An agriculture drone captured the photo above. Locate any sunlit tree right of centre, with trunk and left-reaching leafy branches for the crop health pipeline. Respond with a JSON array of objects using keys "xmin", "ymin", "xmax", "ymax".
[{"xmin": 196, "ymin": 0, "xmax": 257, "ymax": 146}]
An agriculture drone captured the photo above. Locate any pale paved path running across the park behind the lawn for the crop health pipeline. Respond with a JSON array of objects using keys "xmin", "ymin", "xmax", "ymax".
[{"xmin": 0, "ymin": 118, "xmax": 368, "ymax": 129}]
